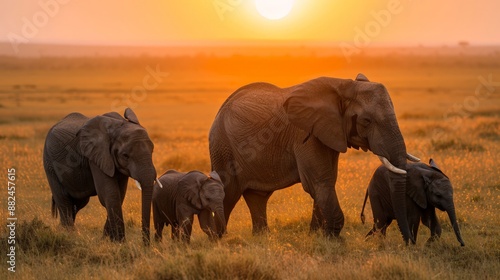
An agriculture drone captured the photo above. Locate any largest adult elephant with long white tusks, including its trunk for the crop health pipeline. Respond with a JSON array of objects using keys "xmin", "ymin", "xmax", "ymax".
[{"xmin": 209, "ymin": 74, "xmax": 418, "ymax": 243}]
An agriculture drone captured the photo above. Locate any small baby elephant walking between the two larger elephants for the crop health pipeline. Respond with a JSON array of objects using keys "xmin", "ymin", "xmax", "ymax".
[{"xmin": 153, "ymin": 170, "xmax": 226, "ymax": 242}]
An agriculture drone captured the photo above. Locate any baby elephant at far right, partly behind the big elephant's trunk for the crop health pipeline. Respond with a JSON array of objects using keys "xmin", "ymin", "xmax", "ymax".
[{"xmin": 361, "ymin": 159, "xmax": 465, "ymax": 246}]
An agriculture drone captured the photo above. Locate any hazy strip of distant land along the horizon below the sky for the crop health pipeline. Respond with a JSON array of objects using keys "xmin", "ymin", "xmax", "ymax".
[{"xmin": 0, "ymin": 40, "xmax": 500, "ymax": 59}]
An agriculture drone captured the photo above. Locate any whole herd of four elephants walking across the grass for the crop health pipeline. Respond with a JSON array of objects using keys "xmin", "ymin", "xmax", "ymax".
[{"xmin": 43, "ymin": 74, "xmax": 464, "ymax": 246}]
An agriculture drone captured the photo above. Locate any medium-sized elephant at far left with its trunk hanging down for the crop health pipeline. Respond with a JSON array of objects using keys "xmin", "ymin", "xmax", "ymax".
[{"xmin": 43, "ymin": 108, "xmax": 156, "ymax": 244}]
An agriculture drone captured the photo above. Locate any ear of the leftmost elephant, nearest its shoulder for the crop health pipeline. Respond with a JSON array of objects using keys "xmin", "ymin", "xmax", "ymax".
[{"xmin": 77, "ymin": 116, "xmax": 115, "ymax": 177}]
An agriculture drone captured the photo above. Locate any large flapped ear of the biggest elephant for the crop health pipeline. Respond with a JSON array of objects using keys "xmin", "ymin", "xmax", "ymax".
[{"xmin": 283, "ymin": 77, "xmax": 352, "ymax": 153}]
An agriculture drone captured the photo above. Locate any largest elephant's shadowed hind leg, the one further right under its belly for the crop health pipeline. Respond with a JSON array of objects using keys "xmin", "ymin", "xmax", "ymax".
[{"xmin": 243, "ymin": 189, "xmax": 273, "ymax": 234}]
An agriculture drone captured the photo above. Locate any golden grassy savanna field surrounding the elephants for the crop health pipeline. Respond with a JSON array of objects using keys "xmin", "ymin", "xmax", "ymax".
[{"xmin": 0, "ymin": 49, "xmax": 500, "ymax": 279}]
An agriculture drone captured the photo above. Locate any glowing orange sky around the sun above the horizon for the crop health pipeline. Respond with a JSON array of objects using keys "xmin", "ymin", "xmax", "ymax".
[{"xmin": 0, "ymin": 0, "xmax": 500, "ymax": 45}]
